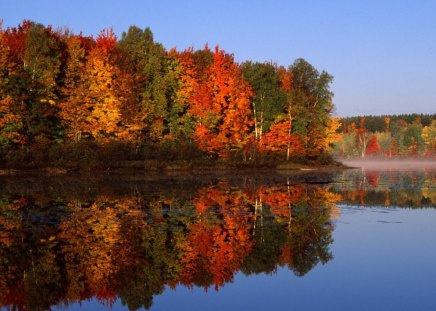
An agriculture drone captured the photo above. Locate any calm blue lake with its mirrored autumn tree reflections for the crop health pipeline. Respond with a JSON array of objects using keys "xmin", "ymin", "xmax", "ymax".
[{"xmin": 0, "ymin": 166, "xmax": 436, "ymax": 310}]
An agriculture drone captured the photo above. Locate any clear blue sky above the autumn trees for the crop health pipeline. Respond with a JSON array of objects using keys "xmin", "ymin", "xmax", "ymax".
[{"xmin": 0, "ymin": 0, "xmax": 436, "ymax": 116}]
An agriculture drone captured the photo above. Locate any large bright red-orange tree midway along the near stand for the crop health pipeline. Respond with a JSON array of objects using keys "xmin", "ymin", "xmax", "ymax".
[{"xmin": 188, "ymin": 47, "xmax": 253, "ymax": 157}]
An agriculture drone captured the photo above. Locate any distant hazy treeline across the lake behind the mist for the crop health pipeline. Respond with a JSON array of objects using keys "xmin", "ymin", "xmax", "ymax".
[{"xmin": 333, "ymin": 114, "xmax": 436, "ymax": 158}]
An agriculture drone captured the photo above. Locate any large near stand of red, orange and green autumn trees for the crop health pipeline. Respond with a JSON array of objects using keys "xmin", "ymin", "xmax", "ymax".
[{"xmin": 0, "ymin": 20, "xmax": 339, "ymax": 169}]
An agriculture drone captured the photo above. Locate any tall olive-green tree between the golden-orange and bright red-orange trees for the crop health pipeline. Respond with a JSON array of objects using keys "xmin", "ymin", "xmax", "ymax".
[{"xmin": 118, "ymin": 26, "xmax": 183, "ymax": 142}]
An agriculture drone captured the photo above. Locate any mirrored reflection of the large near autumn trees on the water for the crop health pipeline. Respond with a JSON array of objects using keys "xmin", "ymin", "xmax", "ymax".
[{"xmin": 0, "ymin": 181, "xmax": 340, "ymax": 310}]
